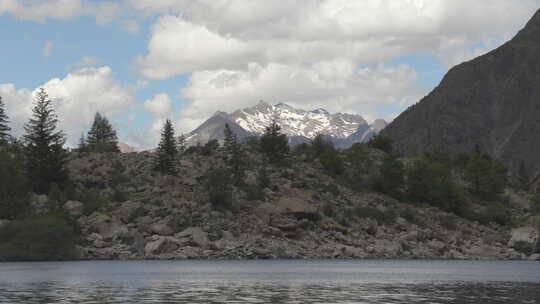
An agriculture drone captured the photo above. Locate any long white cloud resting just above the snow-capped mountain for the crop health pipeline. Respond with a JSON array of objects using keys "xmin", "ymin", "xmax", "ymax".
[{"xmin": 178, "ymin": 61, "xmax": 424, "ymax": 132}]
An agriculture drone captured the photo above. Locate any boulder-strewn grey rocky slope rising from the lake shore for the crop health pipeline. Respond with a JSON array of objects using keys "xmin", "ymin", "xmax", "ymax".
[{"xmin": 25, "ymin": 146, "xmax": 540, "ymax": 259}]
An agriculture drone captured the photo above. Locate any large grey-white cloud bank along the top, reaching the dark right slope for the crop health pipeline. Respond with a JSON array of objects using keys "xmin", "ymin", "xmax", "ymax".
[{"xmin": 136, "ymin": 0, "xmax": 540, "ymax": 79}]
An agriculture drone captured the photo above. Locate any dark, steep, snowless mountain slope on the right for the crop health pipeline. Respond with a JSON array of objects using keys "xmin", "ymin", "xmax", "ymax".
[{"xmin": 383, "ymin": 11, "xmax": 540, "ymax": 180}]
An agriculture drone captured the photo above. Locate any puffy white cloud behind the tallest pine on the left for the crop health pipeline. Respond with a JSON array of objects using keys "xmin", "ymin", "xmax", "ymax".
[{"xmin": 0, "ymin": 66, "xmax": 133, "ymax": 145}]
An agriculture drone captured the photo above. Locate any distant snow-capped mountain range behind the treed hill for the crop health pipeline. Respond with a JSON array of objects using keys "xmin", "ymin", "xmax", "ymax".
[{"xmin": 186, "ymin": 101, "xmax": 386, "ymax": 148}]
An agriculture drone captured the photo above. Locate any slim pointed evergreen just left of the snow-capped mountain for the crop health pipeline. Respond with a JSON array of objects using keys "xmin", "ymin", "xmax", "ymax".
[{"xmin": 155, "ymin": 119, "xmax": 178, "ymax": 175}]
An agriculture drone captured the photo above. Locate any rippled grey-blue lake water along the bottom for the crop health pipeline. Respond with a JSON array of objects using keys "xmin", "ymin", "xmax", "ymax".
[{"xmin": 0, "ymin": 260, "xmax": 540, "ymax": 304}]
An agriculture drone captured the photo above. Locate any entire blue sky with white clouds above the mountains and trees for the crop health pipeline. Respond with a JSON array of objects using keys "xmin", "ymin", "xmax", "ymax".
[{"xmin": 0, "ymin": 0, "xmax": 540, "ymax": 148}]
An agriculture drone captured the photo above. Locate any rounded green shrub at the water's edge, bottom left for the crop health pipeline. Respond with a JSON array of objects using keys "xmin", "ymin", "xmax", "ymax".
[{"xmin": 0, "ymin": 217, "xmax": 78, "ymax": 261}]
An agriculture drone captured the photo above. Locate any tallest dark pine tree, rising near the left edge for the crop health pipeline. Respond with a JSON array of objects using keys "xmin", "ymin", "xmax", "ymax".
[{"xmin": 24, "ymin": 88, "xmax": 68, "ymax": 194}]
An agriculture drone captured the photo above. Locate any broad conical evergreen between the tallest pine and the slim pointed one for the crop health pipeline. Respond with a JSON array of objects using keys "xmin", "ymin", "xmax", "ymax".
[{"xmin": 86, "ymin": 112, "xmax": 120, "ymax": 152}]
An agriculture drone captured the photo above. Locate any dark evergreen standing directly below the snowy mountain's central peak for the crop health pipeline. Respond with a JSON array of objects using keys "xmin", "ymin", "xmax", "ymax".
[{"xmin": 261, "ymin": 121, "xmax": 289, "ymax": 163}]
